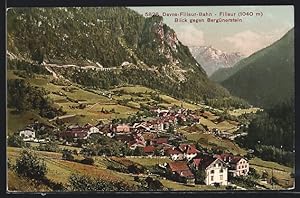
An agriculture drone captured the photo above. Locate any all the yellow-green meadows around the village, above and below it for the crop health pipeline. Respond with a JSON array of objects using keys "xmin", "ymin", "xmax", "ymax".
[{"xmin": 7, "ymin": 70, "xmax": 294, "ymax": 192}]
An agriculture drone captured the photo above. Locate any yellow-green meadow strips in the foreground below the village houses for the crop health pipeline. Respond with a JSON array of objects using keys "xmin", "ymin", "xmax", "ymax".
[{"xmin": 8, "ymin": 147, "xmax": 293, "ymax": 192}]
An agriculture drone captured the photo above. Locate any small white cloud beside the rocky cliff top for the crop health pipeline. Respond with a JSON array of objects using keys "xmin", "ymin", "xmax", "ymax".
[{"xmin": 177, "ymin": 25, "xmax": 204, "ymax": 46}]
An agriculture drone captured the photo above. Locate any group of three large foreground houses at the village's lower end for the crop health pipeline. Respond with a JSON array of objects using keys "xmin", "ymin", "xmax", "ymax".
[{"xmin": 166, "ymin": 153, "xmax": 249, "ymax": 186}]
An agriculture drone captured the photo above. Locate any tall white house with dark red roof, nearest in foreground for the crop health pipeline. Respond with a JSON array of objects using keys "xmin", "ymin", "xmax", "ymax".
[{"xmin": 191, "ymin": 156, "xmax": 228, "ymax": 186}]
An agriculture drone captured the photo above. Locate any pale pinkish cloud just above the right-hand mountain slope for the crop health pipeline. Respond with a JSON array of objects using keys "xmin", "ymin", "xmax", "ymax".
[{"xmin": 223, "ymin": 29, "xmax": 288, "ymax": 56}]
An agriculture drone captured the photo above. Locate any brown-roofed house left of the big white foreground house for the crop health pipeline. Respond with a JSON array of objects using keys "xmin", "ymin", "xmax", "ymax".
[{"xmin": 166, "ymin": 161, "xmax": 195, "ymax": 184}]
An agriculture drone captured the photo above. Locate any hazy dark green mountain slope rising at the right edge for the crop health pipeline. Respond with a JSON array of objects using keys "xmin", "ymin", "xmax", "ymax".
[{"xmin": 221, "ymin": 29, "xmax": 295, "ymax": 108}]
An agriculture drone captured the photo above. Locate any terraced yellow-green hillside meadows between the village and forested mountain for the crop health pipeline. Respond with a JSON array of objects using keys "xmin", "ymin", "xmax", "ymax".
[{"xmin": 8, "ymin": 71, "xmax": 204, "ymax": 133}]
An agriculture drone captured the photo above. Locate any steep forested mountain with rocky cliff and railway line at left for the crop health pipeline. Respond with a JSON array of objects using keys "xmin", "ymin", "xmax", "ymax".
[{"xmin": 7, "ymin": 7, "xmax": 229, "ymax": 101}]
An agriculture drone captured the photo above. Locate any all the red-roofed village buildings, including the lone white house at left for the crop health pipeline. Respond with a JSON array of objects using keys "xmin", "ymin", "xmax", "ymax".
[{"xmin": 19, "ymin": 108, "xmax": 249, "ymax": 185}]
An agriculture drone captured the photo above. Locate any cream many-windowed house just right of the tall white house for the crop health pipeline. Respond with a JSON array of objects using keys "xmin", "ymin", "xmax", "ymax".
[{"xmin": 217, "ymin": 153, "xmax": 249, "ymax": 177}]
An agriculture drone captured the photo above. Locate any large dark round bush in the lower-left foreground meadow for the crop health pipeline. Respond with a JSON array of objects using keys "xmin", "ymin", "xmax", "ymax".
[{"xmin": 15, "ymin": 150, "xmax": 47, "ymax": 180}]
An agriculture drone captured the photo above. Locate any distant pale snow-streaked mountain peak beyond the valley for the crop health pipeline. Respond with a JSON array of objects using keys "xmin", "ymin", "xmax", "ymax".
[{"xmin": 189, "ymin": 46, "xmax": 243, "ymax": 76}]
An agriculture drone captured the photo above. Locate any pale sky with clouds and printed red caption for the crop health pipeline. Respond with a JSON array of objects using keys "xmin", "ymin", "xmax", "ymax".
[{"xmin": 129, "ymin": 5, "xmax": 294, "ymax": 56}]
